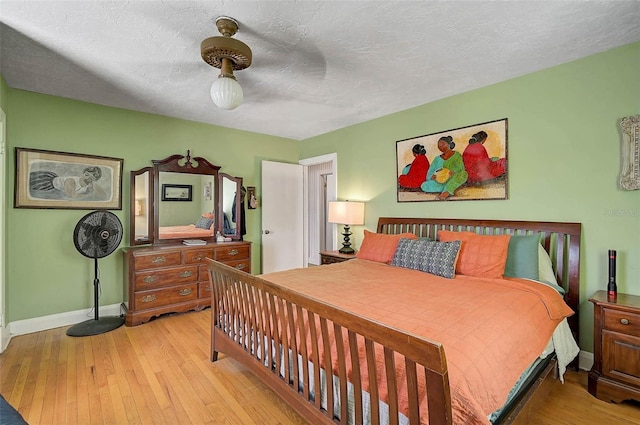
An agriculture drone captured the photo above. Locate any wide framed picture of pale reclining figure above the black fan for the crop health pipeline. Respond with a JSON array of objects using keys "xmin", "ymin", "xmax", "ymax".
[{"xmin": 14, "ymin": 147, "xmax": 124, "ymax": 210}]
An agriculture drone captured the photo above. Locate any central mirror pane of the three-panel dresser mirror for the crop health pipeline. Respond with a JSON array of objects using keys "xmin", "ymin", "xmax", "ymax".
[{"xmin": 158, "ymin": 171, "xmax": 216, "ymax": 239}]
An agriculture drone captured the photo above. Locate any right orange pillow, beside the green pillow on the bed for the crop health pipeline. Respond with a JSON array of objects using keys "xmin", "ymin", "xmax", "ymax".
[{"xmin": 438, "ymin": 230, "xmax": 511, "ymax": 278}]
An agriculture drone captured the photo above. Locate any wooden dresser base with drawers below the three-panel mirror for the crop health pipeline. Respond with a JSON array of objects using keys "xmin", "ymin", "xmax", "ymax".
[{"xmin": 122, "ymin": 242, "xmax": 251, "ymax": 326}]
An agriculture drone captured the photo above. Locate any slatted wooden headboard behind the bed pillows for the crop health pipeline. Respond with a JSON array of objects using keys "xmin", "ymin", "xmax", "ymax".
[{"xmin": 377, "ymin": 217, "xmax": 582, "ymax": 341}]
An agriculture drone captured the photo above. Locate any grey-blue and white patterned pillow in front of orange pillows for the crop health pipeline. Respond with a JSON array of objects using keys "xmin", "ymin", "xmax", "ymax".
[{"xmin": 391, "ymin": 238, "xmax": 462, "ymax": 279}]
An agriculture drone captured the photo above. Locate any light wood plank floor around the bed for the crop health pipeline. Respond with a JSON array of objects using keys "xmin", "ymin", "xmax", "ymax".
[{"xmin": 0, "ymin": 310, "xmax": 640, "ymax": 425}]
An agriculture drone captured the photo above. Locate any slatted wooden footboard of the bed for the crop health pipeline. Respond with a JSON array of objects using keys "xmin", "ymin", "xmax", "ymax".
[{"xmin": 207, "ymin": 260, "xmax": 452, "ymax": 425}]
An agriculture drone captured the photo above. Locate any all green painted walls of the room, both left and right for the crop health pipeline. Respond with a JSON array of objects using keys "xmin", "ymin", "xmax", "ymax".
[{"xmin": 0, "ymin": 43, "xmax": 640, "ymax": 351}]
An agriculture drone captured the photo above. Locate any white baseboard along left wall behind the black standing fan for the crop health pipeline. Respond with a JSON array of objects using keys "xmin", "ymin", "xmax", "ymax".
[{"xmin": 7, "ymin": 304, "xmax": 122, "ymax": 337}]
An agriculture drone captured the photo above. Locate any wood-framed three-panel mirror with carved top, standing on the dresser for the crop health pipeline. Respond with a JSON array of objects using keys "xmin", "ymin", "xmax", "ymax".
[{"xmin": 130, "ymin": 151, "xmax": 243, "ymax": 246}]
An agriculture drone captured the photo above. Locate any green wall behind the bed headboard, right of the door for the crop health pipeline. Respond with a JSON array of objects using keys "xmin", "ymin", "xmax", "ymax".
[{"xmin": 301, "ymin": 43, "xmax": 640, "ymax": 351}]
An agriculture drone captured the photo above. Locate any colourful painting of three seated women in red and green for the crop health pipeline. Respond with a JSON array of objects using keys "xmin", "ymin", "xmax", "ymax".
[{"xmin": 395, "ymin": 118, "xmax": 508, "ymax": 202}]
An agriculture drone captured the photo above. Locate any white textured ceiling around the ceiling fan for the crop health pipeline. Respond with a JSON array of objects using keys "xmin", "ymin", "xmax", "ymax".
[{"xmin": 0, "ymin": 0, "xmax": 640, "ymax": 139}]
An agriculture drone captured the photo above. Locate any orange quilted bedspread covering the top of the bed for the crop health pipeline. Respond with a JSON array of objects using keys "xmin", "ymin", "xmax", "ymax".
[{"xmin": 262, "ymin": 259, "xmax": 573, "ymax": 424}]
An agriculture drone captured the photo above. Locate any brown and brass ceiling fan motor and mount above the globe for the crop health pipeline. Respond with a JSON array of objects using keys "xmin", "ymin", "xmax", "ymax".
[{"xmin": 200, "ymin": 16, "xmax": 252, "ymax": 71}]
